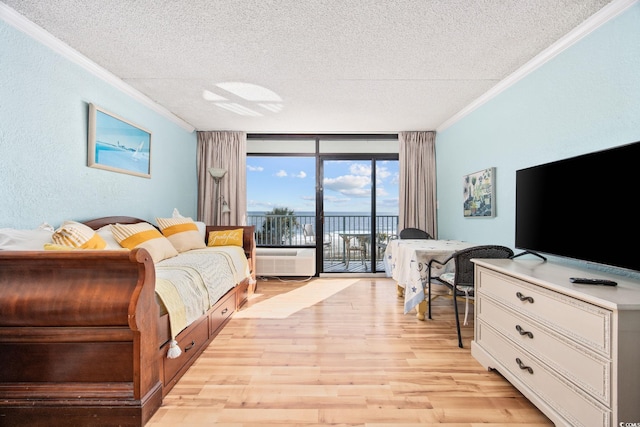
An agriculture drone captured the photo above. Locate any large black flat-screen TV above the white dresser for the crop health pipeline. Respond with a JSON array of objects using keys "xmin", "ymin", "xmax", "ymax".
[{"xmin": 515, "ymin": 142, "xmax": 640, "ymax": 271}]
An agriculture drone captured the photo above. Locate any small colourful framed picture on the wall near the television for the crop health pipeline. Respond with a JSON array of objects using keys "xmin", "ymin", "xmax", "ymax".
[{"xmin": 463, "ymin": 167, "xmax": 496, "ymax": 218}]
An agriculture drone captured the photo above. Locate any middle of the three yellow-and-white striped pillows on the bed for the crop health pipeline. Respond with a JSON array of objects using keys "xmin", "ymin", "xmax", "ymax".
[{"xmin": 111, "ymin": 222, "xmax": 178, "ymax": 262}]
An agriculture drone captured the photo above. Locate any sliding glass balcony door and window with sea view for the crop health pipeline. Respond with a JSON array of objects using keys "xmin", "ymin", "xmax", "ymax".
[{"xmin": 247, "ymin": 135, "xmax": 399, "ymax": 272}]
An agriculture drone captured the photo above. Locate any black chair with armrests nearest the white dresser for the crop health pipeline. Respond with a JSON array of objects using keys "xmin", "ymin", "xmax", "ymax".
[{"xmin": 427, "ymin": 245, "xmax": 513, "ymax": 348}]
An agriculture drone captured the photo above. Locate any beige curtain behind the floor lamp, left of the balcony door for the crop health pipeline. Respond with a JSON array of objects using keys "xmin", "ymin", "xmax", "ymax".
[{"xmin": 197, "ymin": 132, "xmax": 247, "ymax": 225}]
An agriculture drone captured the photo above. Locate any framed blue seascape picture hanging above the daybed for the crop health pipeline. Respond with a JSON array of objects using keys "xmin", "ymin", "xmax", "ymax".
[{"xmin": 87, "ymin": 104, "xmax": 151, "ymax": 178}]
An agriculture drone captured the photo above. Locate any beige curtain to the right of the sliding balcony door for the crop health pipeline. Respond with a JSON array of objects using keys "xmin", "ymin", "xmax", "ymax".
[{"xmin": 398, "ymin": 132, "xmax": 438, "ymax": 238}]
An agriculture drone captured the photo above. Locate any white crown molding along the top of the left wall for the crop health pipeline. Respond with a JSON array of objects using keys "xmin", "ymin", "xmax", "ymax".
[{"xmin": 0, "ymin": 3, "xmax": 195, "ymax": 132}]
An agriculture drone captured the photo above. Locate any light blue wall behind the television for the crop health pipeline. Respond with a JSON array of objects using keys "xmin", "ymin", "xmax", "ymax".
[{"xmin": 436, "ymin": 4, "xmax": 640, "ymax": 274}]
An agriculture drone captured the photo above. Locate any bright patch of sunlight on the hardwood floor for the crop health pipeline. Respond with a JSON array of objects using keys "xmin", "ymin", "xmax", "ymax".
[{"xmin": 233, "ymin": 279, "xmax": 359, "ymax": 319}]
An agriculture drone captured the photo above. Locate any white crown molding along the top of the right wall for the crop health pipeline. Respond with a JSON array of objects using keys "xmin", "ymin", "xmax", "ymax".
[{"xmin": 436, "ymin": 0, "xmax": 639, "ymax": 132}]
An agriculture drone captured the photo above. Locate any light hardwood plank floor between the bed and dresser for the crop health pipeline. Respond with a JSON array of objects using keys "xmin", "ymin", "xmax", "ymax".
[{"xmin": 147, "ymin": 278, "xmax": 553, "ymax": 427}]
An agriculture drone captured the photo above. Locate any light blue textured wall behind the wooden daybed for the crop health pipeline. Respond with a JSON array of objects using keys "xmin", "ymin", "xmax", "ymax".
[{"xmin": 0, "ymin": 20, "xmax": 197, "ymax": 228}]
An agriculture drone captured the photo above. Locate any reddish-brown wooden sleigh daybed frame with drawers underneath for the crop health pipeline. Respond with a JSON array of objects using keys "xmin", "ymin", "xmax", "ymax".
[{"xmin": 0, "ymin": 217, "xmax": 255, "ymax": 426}]
